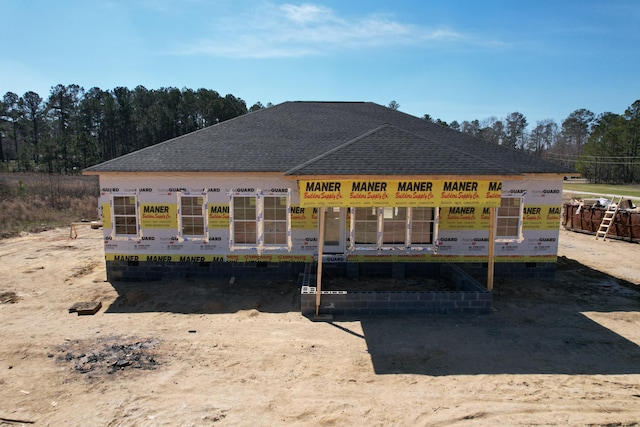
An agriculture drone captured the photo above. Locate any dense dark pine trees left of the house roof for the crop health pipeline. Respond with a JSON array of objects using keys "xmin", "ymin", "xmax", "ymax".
[{"xmin": 0, "ymin": 84, "xmax": 264, "ymax": 174}]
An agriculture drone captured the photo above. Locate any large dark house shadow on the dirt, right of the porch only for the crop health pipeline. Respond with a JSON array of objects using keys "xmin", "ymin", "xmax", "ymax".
[{"xmin": 360, "ymin": 258, "xmax": 640, "ymax": 376}]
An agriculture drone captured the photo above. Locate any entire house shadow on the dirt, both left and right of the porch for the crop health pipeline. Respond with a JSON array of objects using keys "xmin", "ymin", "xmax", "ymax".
[{"xmin": 106, "ymin": 257, "xmax": 640, "ymax": 376}]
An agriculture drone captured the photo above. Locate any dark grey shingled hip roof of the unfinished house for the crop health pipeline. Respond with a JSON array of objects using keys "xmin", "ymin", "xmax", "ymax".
[{"xmin": 85, "ymin": 102, "xmax": 572, "ymax": 176}]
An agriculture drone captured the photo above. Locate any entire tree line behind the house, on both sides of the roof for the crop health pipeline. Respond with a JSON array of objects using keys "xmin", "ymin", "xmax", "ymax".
[{"xmin": 0, "ymin": 88, "xmax": 640, "ymax": 183}]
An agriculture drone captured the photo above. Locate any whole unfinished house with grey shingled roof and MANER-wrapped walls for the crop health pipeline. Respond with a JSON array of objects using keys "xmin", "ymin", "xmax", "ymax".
[{"xmin": 84, "ymin": 102, "xmax": 572, "ymax": 286}]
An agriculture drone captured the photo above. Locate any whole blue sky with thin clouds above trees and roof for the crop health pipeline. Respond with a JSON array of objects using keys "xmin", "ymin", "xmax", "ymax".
[{"xmin": 0, "ymin": 0, "xmax": 640, "ymax": 129}]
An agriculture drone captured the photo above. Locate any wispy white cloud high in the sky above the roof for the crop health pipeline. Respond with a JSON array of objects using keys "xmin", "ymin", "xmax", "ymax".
[{"xmin": 174, "ymin": 3, "xmax": 476, "ymax": 58}]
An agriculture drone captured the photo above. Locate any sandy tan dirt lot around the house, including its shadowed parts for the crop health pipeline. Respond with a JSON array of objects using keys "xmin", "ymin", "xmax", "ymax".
[{"xmin": 0, "ymin": 227, "xmax": 640, "ymax": 426}]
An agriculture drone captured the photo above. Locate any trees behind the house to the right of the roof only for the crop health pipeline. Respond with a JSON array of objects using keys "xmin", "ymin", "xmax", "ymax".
[{"xmin": 418, "ymin": 100, "xmax": 640, "ymax": 184}]
